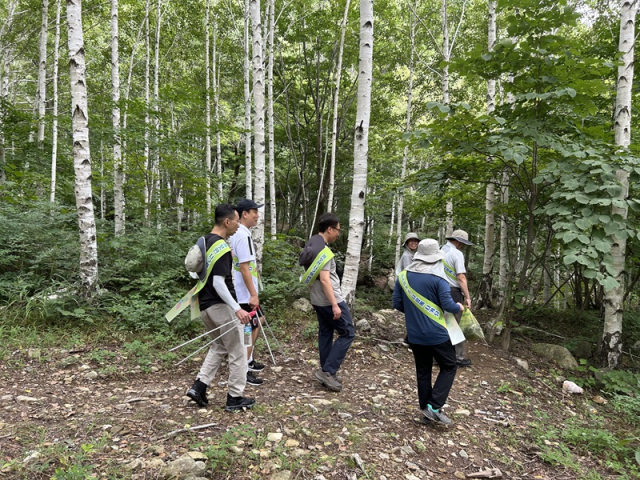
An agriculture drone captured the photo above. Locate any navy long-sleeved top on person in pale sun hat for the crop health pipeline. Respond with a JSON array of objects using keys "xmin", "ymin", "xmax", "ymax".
[{"xmin": 393, "ymin": 272, "xmax": 460, "ymax": 345}]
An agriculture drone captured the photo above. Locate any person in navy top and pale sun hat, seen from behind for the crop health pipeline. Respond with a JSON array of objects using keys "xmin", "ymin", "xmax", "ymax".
[{"xmin": 393, "ymin": 238, "xmax": 464, "ymax": 425}]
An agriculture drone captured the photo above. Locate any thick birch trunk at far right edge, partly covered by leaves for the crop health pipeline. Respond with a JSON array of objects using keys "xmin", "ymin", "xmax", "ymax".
[{"xmin": 601, "ymin": 0, "xmax": 638, "ymax": 368}]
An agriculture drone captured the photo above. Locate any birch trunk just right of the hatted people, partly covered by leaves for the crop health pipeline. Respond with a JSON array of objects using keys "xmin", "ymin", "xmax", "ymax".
[{"xmin": 478, "ymin": 0, "xmax": 496, "ymax": 308}]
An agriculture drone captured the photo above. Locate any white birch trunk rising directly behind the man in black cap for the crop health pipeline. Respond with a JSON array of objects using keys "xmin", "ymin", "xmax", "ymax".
[{"xmin": 250, "ymin": 0, "xmax": 265, "ymax": 268}]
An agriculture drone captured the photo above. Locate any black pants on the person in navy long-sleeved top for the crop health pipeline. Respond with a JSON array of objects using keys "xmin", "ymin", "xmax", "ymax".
[{"xmin": 411, "ymin": 340, "xmax": 458, "ymax": 410}]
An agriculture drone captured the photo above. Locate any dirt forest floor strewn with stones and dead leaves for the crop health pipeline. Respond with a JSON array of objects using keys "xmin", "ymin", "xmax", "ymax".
[{"xmin": 0, "ymin": 310, "xmax": 638, "ymax": 480}]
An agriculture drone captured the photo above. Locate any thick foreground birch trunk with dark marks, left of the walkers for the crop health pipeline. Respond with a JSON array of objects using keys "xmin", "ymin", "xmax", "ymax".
[{"xmin": 67, "ymin": 0, "xmax": 98, "ymax": 296}]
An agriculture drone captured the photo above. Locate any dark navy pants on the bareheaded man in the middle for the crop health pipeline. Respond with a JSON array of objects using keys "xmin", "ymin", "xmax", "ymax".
[{"xmin": 313, "ymin": 302, "xmax": 356, "ymax": 375}]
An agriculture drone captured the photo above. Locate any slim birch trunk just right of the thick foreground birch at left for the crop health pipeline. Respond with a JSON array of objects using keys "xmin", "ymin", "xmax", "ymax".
[{"xmin": 111, "ymin": 0, "xmax": 125, "ymax": 236}]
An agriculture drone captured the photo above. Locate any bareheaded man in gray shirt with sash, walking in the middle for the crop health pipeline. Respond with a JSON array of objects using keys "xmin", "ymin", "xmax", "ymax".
[{"xmin": 299, "ymin": 213, "xmax": 355, "ymax": 392}]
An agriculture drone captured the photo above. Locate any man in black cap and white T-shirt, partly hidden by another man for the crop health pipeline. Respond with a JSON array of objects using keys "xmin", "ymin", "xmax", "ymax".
[{"xmin": 229, "ymin": 198, "xmax": 265, "ymax": 386}]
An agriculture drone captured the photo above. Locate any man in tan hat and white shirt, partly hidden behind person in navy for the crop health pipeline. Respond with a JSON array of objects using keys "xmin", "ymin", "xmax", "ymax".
[{"xmin": 440, "ymin": 230, "xmax": 473, "ymax": 367}]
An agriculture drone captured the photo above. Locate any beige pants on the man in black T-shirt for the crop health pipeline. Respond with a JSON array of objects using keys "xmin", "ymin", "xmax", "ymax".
[{"xmin": 198, "ymin": 303, "xmax": 248, "ymax": 397}]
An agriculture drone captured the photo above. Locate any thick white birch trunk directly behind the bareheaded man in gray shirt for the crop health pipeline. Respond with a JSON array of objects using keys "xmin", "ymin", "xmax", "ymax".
[{"xmin": 342, "ymin": 0, "xmax": 373, "ymax": 307}]
